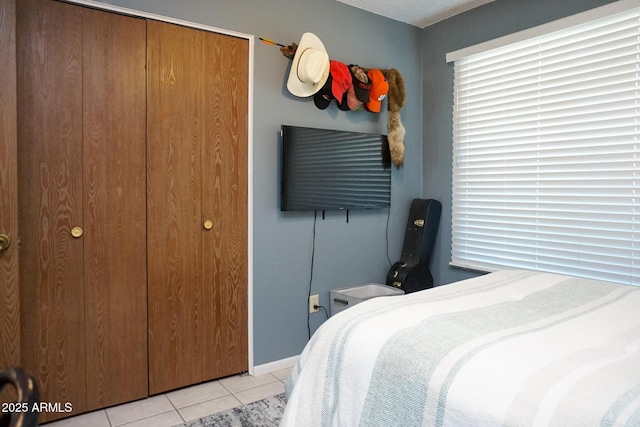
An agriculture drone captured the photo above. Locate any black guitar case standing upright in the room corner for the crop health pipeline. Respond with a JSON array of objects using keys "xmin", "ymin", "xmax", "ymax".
[{"xmin": 387, "ymin": 199, "xmax": 442, "ymax": 294}]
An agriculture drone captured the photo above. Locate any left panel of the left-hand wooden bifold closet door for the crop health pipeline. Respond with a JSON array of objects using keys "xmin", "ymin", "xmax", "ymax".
[{"xmin": 17, "ymin": 0, "xmax": 86, "ymax": 414}]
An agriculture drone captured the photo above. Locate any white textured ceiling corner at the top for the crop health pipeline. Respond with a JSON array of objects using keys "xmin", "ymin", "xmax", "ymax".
[{"xmin": 338, "ymin": 0, "xmax": 493, "ymax": 28}]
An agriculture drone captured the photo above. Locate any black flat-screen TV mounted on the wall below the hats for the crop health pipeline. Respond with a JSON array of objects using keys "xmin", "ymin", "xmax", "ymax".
[{"xmin": 280, "ymin": 125, "xmax": 391, "ymax": 211}]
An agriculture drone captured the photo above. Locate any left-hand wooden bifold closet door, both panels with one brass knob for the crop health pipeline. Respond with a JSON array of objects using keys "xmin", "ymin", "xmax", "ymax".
[{"xmin": 18, "ymin": 0, "xmax": 148, "ymax": 421}]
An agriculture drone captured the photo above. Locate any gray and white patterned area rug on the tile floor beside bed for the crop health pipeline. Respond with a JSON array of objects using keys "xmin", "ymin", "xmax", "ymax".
[{"xmin": 176, "ymin": 393, "xmax": 285, "ymax": 427}]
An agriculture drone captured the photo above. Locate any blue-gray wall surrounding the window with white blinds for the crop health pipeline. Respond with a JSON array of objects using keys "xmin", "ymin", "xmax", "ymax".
[{"xmin": 422, "ymin": 0, "xmax": 611, "ymax": 290}]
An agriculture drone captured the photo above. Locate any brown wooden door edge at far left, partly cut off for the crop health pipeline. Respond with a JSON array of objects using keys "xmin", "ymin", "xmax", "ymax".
[{"xmin": 0, "ymin": 0, "xmax": 20, "ymax": 370}]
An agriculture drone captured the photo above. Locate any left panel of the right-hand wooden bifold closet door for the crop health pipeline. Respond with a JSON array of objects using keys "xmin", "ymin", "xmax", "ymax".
[{"xmin": 147, "ymin": 21, "xmax": 207, "ymax": 394}]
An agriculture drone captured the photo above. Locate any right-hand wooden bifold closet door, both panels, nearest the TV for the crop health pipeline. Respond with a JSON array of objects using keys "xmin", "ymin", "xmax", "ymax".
[{"xmin": 147, "ymin": 22, "xmax": 248, "ymax": 394}]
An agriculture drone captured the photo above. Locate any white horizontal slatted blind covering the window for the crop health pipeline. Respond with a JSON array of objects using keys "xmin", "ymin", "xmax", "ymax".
[{"xmin": 451, "ymin": 8, "xmax": 640, "ymax": 285}]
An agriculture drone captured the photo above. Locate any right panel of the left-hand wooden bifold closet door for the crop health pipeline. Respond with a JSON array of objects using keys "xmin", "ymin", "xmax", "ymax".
[{"xmin": 83, "ymin": 8, "xmax": 148, "ymax": 408}]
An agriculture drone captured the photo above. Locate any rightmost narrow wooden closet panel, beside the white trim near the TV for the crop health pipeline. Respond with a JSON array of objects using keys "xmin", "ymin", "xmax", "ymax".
[{"xmin": 202, "ymin": 33, "xmax": 249, "ymax": 378}]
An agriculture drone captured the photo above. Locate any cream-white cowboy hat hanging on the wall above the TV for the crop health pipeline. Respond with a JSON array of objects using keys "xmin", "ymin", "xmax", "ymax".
[{"xmin": 287, "ymin": 33, "xmax": 330, "ymax": 97}]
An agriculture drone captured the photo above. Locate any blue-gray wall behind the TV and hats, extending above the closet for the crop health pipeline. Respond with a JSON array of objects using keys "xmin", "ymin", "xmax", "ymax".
[{"xmin": 95, "ymin": 0, "xmax": 422, "ymax": 365}]
